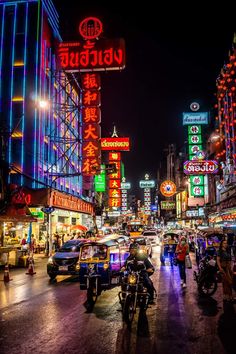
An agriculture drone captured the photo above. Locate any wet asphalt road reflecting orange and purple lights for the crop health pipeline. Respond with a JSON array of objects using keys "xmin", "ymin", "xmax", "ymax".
[{"xmin": 0, "ymin": 247, "xmax": 236, "ymax": 354}]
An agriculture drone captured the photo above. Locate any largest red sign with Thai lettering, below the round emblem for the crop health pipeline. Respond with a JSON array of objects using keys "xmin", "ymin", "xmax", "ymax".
[{"xmin": 56, "ymin": 39, "xmax": 125, "ymax": 72}]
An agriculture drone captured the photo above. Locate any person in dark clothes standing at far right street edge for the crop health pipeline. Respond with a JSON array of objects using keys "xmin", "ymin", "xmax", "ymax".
[{"xmin": 216, "ymin": 239, "xmax": 233, "ymax": 301}]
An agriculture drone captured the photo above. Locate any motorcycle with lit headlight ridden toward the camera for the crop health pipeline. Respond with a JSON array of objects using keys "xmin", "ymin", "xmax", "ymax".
[{"xmin": 118, "ymin": 260, "xmax": 150, "ymax": 325}]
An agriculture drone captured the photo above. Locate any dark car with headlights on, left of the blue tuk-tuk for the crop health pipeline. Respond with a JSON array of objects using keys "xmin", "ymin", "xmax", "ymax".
[{"xmin": 47, "ymin": 239, "xmax": 88, "ymax": 280}]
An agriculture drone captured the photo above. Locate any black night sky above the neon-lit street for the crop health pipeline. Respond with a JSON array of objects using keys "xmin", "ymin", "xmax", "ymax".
[{"xmin": 53, "ymin": 0, "xmax": 236, "ymax": 195}]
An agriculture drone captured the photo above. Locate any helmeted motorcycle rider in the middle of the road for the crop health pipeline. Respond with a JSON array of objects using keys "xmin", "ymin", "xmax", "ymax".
[{"xmin": 121, "ymin": 242, "xmax": 155, "ymax": 303}]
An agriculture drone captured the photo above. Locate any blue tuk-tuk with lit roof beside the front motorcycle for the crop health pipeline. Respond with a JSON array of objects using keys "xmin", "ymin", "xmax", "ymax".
[{"xmin": 79, "ymin": 236, "xmax": 129, "ymax": 312}]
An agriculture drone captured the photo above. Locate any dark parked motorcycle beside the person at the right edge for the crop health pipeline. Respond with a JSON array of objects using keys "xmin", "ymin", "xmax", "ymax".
[{"xmin": 194, "ymin": 256, "xmax": 220, "ymax": 296}]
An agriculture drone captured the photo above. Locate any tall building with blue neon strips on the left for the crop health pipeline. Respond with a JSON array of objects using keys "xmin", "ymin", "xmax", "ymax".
[{"xmin": 0, "ymin": 0, "xmax": 92, "ymax": 249}]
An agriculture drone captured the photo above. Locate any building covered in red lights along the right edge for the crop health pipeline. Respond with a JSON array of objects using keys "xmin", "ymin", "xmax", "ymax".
[{"xmin": 206, "ymin": 34, "xmax": 236, "ymax": 231}]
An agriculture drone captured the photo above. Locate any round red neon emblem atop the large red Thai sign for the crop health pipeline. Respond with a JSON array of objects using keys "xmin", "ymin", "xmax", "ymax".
[{"xmin": 79, "ymin": 17, "xmax": 103, "ymax": 39}]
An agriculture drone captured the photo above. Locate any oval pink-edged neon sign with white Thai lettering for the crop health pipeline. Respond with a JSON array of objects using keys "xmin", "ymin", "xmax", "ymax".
[{"xmin": 184, "ymin": 160, "xmax": 218, "ymax": 175}]
